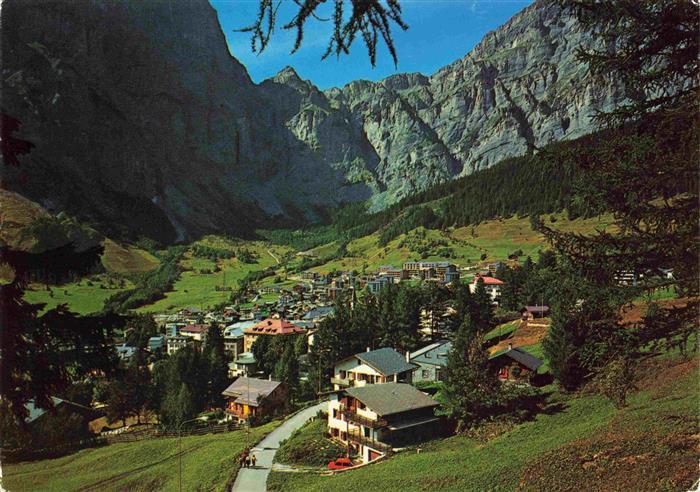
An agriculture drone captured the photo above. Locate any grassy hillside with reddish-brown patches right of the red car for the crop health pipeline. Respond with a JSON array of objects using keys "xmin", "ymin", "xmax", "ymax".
[{"xmin": 268, "ymin": 358, "xmax": 697, "ymax": 491}]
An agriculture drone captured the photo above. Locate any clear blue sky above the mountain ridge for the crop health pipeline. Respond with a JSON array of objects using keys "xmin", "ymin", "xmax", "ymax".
[{"xmin": 210, "ymin": 0, "xmax": 531, "ymax": 89}]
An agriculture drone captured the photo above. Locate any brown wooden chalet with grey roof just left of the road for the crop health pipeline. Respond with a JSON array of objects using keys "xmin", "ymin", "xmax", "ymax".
[{"xmin": 221, "ymin": 376, "xmax": 288, "ymax": 420}]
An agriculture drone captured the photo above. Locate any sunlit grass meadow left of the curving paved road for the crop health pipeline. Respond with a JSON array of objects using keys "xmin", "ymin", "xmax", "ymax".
[{"xmin": 2, "ymin": 421, "xmax": 279, "ymax": 492}]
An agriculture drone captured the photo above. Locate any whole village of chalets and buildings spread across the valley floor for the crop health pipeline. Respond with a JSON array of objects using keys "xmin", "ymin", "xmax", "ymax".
[{"xmin": 89, "ymin": 261, "xmax": 549, "ymax": 469}]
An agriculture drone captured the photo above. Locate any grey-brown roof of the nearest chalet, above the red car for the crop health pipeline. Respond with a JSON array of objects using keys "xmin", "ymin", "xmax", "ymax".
[{"xmin": 345, "ymin": 383, "xmax": 439, "ymax": 416}]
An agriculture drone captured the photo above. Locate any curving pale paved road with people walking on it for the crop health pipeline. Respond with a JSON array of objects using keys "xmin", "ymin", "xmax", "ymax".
[{"xmin": 231, "ymin": 401, "xmax": 328, "ymax": 492}]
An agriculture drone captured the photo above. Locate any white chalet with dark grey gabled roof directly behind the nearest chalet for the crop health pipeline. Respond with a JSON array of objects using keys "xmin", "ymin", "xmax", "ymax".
[{"xmin": 331, "ymin": 347, "xmax": 417, "ymax": 390}]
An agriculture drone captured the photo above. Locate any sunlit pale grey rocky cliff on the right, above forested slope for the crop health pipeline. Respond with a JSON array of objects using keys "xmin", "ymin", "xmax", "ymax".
[{"xmin": 320, "ymin": 1, "xmax": 623, "ymax": 208}]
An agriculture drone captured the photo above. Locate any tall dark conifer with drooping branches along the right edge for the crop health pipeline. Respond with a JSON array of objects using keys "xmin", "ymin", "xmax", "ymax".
[{"xmin": 537, "ymin": 0, "xmax": 699, "ymax": 396}]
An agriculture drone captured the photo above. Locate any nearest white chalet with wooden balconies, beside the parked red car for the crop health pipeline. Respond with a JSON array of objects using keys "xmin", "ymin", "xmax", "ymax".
[{"xmin": 328, "ymin": 383, "xmax": 439, "ymax": 462}]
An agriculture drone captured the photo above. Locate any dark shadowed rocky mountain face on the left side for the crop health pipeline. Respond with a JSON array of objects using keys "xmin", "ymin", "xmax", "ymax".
[{"xmin": 2, "ymin": 0, "xmax": 377, "ymax": 241}]
